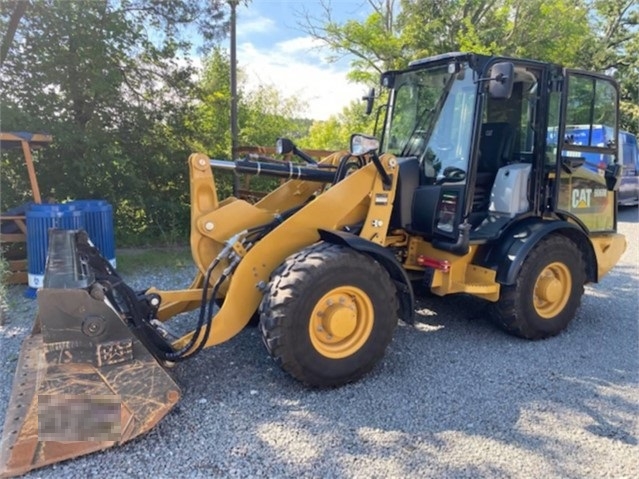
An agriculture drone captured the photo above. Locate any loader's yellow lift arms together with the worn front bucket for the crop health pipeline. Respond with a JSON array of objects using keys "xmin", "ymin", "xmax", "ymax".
[{"xmin": 0, "ymin": 144, "xmax": 397, "ymax": 476}]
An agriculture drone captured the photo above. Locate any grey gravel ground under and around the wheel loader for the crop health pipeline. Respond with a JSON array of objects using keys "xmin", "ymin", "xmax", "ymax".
[{"xmin": 0, "ymin": 208, "xmax": 639, "ymax": 478}]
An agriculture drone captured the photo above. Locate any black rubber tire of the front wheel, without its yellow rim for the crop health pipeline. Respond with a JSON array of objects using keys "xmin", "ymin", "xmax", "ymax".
[{"xmin": 261, "ymin": 244, "xmax": 398, "ymax": 386}]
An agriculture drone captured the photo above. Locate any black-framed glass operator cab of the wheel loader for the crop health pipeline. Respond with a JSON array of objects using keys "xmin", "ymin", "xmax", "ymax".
[{"xmin": 380, "ymin": 53, "xmax": 618, "ymax": 254}]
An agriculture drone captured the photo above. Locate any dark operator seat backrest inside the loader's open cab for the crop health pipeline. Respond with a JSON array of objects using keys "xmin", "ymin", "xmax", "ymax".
[{"xmin": 471, "ymin": 122, "xmax": 515, "ymax": 213}]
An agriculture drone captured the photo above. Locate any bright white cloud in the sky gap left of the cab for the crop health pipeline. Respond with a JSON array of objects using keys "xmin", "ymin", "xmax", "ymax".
[{"xmin": 237, "ymin": 37, "xmax": 366, "ymax": 120}]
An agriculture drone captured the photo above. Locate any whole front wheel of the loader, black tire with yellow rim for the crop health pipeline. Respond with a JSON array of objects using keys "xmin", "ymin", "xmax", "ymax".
[{"xmin": 260, "ymin": 243, "xmax": 398, "ymax": 387}]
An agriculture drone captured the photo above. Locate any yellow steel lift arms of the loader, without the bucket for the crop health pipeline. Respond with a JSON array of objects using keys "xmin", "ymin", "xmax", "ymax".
[{"xmin": 156, "ymin": 148, "xmax": 396, "ymax": 354}]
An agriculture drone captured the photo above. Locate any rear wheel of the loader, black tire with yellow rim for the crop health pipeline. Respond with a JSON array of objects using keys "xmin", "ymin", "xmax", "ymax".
[{"xmin": 491, "ymin": 235, "xmax": 586, "ymax": 339}]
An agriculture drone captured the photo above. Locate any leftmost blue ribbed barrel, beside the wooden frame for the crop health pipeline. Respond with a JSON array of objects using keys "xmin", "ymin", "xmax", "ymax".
[{"xmin": 25, "ymin": 203, "xmax": 84, "ymax": 298}]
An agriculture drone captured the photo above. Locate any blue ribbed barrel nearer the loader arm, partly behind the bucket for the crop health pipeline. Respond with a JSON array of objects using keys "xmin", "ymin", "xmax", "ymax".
[{"xmin": 71, "ymin": 200, "xmax": 116, "ymax": 268}]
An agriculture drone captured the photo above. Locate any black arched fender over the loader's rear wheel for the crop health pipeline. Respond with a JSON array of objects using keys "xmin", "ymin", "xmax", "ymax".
[{"xmin": 478, "ymin": 218, "xmax": 597, "ymax": 285}]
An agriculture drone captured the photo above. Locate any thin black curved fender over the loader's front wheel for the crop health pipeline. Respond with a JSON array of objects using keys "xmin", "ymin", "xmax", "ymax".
[{"xmin": 318, "ymin": 230, "xmax": 415, "ymax": 323}]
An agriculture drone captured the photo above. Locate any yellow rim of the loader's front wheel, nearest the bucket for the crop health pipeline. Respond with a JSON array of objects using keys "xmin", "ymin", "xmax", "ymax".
[{"xmin": 308, "ymin": 286, "xmax": 375, "ymax": 359}]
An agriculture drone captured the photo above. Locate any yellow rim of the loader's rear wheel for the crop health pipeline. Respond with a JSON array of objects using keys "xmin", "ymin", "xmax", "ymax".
[{"xmin": 533, "ymin": 263, "xmax": 572, "ymax": 319}]
